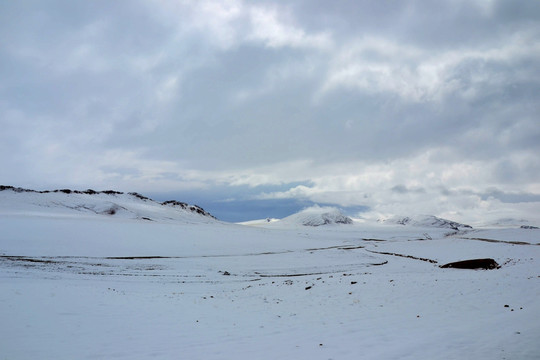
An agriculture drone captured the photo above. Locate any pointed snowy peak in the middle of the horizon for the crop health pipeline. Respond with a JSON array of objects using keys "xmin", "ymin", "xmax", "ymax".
[{"xmin": 281, "ymin": 205, "xmax": 353, "ymax": 226}]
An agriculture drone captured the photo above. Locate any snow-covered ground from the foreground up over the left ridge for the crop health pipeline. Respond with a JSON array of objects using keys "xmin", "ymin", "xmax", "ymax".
[{"xmin": 0, "ymin": 190, "xmax": 540, "ymax": 359}]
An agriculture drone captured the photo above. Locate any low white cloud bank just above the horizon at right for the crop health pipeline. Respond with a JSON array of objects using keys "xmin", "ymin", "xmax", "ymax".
[{"xmin": 251, "ymin": 150, "xmax": 540, "ymax": 222}]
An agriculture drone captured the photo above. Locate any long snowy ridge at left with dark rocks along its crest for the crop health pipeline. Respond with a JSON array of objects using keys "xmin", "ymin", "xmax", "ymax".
[{"xmin": 0, "ymin": 185, "xmax": 216, "ymax": 222}]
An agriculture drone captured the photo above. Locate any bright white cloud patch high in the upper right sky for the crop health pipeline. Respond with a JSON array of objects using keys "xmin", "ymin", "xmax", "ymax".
[{"xmin": 318, "ymin": 31, "xmax": 540, "ymax": 102}]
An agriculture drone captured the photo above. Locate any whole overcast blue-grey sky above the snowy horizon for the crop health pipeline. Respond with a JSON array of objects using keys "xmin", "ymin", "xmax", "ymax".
[{"xmin": 0, "ymin": 0, "xmax": 540, "ymax": 225}]
